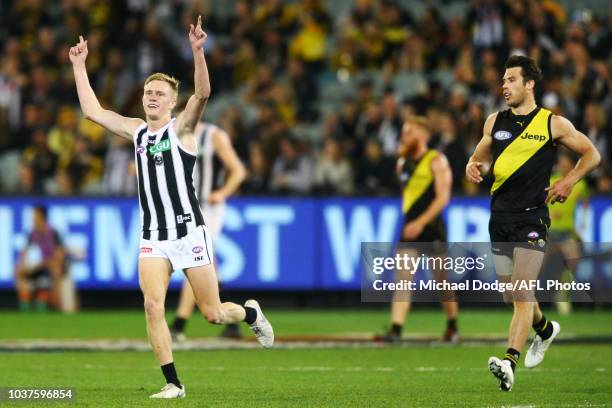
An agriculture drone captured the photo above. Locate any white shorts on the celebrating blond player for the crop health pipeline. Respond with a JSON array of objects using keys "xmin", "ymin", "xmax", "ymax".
[{"xmin": 140, "ymin": 225, "xmax": 214, "ymax": 270}]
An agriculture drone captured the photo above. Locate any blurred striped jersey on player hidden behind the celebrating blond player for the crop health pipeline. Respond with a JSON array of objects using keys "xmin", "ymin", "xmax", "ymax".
[{"xmin": 195, "ymin": 122, "xmax": 226, "ymax": 203}]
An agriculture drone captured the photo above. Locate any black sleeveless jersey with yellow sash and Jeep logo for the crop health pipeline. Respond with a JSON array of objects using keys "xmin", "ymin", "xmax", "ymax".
[{"xmin": 491, "ymin": 107, "xmax": 556, "ymax": 213}]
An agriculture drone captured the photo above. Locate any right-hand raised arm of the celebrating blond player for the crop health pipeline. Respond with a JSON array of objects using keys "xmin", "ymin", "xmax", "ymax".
[{"xmin": 174, "ymin": 16, "xmax": 210, "ymax": 151}]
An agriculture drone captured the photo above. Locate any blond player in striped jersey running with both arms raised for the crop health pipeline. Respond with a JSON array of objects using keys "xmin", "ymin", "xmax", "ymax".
[{"xmin": 69, "ymin": 17, "xmax": 274, "ymax": 398}]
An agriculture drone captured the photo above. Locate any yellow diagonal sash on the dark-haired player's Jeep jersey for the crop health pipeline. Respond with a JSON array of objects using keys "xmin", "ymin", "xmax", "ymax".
[{"xmin": 491, "ymin": 109, "xmax": 551, "ymax": 194}]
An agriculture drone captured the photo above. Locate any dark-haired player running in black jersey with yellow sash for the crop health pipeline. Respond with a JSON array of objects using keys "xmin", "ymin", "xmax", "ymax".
[{"xmin": 466, "ymin": 55, "xmax": 600, "ymax": 391}]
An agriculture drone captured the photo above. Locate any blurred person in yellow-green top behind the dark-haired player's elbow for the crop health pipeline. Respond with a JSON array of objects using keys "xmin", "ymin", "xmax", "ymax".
[{"xmin": 546, "ymin": 149, "xmax": 590, "ymax": 315}]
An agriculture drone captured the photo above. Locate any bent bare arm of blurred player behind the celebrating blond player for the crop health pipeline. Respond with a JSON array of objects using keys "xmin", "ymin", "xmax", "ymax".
[{"xmin": 208, "ymin": 129, "xmax": 246, "ymax": 204}]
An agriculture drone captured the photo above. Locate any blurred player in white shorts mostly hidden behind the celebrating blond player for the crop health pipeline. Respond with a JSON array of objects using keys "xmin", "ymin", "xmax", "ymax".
[{"xmin": 170, "ymin": 122, "xmax": 246, "ymax": 341}]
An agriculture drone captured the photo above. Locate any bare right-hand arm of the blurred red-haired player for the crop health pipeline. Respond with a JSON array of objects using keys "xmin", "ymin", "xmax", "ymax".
[{"xmin": 403, "ymin": 153, "xmax": 453, "ymax": 239}]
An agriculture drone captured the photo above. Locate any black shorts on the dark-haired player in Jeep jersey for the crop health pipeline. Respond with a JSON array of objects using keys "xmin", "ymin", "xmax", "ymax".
[{"xmin": 489, "ymin": 207, "xmax": 550, "ymax": 257}]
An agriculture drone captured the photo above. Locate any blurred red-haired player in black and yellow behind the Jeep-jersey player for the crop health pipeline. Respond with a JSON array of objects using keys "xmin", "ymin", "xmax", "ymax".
[{"xmin": 383, "ymin": 117, "xmax": 459, "ymax": 342}]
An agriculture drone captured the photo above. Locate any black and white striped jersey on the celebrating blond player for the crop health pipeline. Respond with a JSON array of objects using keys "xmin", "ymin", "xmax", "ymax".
[{"xmin": 134, "ymin": 119, "xmax": 204, "ymax": 241}]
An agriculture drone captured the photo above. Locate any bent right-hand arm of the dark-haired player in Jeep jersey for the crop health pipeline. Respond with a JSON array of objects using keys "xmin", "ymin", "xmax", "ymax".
[{"xmin": 546, "ymin": 115, "xmax": 601, "ymax": 204}]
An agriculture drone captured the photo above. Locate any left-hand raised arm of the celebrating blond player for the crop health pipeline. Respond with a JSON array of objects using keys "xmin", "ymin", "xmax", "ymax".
[{"xmin": 69, "ymin": 36, "xmax": 143, "ymax": 140}]
